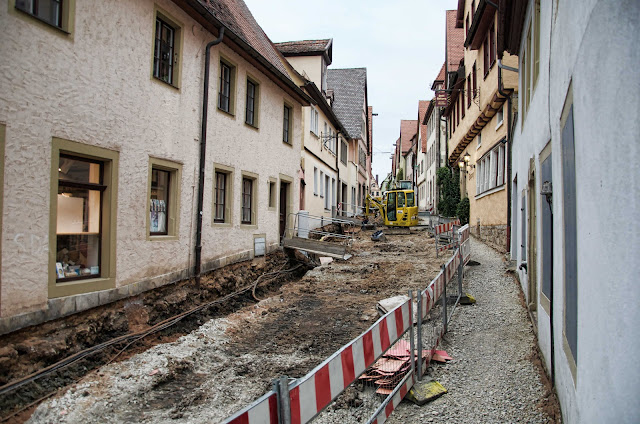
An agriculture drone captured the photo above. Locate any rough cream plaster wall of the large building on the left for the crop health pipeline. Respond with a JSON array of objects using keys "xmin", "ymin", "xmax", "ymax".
[{"xmin": 0, "ymin": 0, "xmax": 301, "ymax": 317}]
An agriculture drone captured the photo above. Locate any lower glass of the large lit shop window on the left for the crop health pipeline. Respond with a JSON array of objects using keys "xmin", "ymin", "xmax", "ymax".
[{"xmin": 56, "ymin": 182, "xmax": 101, "ymax": 279}]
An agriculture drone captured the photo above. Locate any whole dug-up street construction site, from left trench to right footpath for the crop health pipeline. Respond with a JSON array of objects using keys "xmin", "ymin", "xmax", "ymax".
[{"xmin": 0, "ymin": 210, "xmax": 559, "ymax": 423}]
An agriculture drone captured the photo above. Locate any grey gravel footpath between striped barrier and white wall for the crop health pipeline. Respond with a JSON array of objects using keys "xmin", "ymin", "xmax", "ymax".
[{"xmin": 387, "ymin": 238, "xmax": 554, "ymax": 424}]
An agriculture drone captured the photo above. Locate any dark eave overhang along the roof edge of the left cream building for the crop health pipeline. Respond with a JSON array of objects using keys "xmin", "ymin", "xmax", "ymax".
[{"xmin": 173, "ymin": 0, "xmax": 315, "ymax": 106}]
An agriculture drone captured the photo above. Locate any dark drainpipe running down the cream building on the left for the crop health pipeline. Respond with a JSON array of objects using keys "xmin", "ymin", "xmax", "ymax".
[{"xmin": 194, "ymin": 27, "xmax": 224, "ymax": 287}]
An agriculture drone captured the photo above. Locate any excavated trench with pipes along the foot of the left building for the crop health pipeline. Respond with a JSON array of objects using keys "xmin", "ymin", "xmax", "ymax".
[{"xmin": 0, "ymin": 252, "xmax": 310, "ymax": 422}]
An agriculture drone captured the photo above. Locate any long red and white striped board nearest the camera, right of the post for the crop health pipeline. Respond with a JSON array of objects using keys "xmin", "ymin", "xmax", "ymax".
[{"xmin": 289, "ymin": 300, "xmax": 412, "ymax": 424}]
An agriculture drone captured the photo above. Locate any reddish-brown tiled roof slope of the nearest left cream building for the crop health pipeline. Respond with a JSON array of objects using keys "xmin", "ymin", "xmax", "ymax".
[{"xmin": 197, "ymin": 0, "xmax": 291, "ymax": 79}]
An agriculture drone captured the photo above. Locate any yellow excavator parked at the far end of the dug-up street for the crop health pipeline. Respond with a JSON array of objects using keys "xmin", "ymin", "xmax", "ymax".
[{"xmin": 365, "ymin": 189, "xmax": 418, "ymax": 227}]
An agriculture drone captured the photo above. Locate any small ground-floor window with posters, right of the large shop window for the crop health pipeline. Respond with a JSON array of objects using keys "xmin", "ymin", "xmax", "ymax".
[{"xmin": 148, "ymin": 158, "xmax": 181, "ymax": 237}]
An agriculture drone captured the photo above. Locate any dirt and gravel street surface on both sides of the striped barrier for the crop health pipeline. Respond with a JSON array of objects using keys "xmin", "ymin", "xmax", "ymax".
[{"xmin": 22, "ymin": 231, "xmax": 552, "ymax": 423}]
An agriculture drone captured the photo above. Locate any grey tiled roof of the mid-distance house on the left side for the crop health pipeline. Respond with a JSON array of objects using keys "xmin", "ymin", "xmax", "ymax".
[{"xmin": 327, "ymin": 68, "xmax": 367, "ymax": 139}]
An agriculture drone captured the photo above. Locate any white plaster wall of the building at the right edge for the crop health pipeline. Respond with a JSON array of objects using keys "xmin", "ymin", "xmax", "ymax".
[{"xmin": 512, "ymin": 0, "xmax": 640, "ymax": 423}]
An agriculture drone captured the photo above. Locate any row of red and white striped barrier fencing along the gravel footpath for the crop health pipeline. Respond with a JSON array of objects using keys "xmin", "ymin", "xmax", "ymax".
[{"xmin": 223, "ymin": 224, "xmax": 470, "ymax": 424}]
